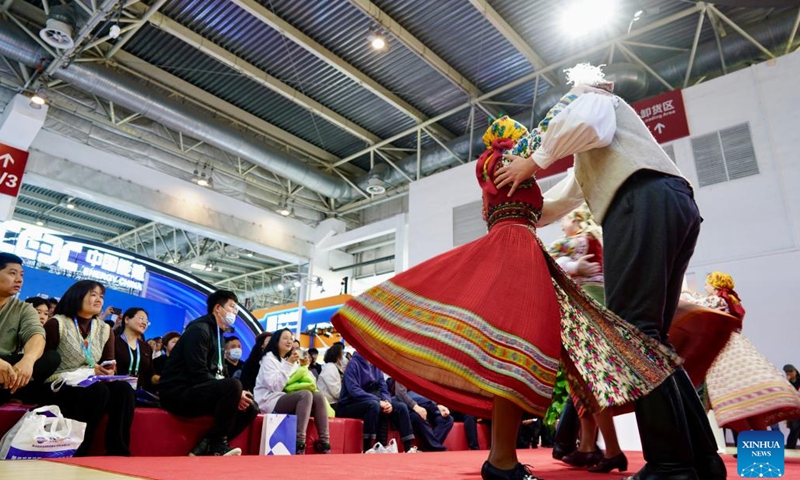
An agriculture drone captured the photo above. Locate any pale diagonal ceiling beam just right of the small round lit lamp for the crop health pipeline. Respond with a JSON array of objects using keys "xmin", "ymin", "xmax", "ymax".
[{"xmin": 349, "ymin": 0, "xmax": 497, "ymax": 115}]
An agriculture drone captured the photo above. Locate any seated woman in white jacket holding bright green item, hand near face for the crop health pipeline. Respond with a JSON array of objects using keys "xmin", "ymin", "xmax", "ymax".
[{"xmin": 254, "ymin": 328, "xmax": 331, "ymax": 454}]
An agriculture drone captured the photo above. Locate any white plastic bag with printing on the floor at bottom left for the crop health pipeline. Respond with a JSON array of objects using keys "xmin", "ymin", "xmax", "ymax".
[{"xmin": 0, "ymin": 405, "xmax": 86, "ymax": 460}]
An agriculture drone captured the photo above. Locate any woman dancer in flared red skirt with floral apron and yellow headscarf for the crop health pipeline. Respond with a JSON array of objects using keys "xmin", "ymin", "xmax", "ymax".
[{"xmin": 332, "ymin": 108, "xmax": 680, "ymax": 480}]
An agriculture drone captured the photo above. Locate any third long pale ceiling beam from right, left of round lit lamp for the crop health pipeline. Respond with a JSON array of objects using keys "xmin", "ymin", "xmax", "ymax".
[{"xmin": 231, "ymin": 0, "xmax": 454, "ymax": 140}]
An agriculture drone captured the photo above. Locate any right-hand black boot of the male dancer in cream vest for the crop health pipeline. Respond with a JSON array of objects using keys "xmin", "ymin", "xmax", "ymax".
[{"xmin": 673, "ymin": 369, "xmax": 728, "ymax": 480}]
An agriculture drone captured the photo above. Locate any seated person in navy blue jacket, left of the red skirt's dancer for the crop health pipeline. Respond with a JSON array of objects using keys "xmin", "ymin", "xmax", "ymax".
[{"xmin": 336, "ymin": 352, "xmax": 417, "ymax": 452}]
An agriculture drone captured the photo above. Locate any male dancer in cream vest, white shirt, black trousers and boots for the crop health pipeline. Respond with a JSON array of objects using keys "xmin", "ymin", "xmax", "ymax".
[{"xmin": 497, "ymin": 65, "xmax": 727, "ymax": 480}]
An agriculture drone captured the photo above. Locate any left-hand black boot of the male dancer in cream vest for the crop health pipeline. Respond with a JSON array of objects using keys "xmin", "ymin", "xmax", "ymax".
[{"xmin": 627, "ymin": 375, "xmax": 706, "ymax": 480}]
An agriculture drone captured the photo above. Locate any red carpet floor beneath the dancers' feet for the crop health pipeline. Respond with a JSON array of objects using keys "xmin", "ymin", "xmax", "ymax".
[{"xmin": 54, "ymin": 448, "xmax": 800, "ymax": 480}]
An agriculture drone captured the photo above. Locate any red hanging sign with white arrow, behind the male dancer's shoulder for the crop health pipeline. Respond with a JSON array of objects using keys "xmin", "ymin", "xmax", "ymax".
[{"xmin": 631, "ymin": 90, "xmax": 689, "ymax": 143}]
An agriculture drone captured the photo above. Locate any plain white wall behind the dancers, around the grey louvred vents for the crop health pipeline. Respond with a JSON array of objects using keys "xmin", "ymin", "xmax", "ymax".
[{"xmin": 409, "ymin": 52, "xmax": 800, "ymax": 366}]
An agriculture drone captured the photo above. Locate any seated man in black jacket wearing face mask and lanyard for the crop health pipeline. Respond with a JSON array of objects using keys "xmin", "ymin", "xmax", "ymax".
[{"xmin": 159, "ymin": 290, "xmax": 258, "ymax": 456}]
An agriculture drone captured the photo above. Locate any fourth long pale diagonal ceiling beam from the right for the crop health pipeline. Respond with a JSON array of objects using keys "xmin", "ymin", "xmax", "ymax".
[{"xmin": 142, "ymin": 8, "xmax": 380, "ymax": 144}]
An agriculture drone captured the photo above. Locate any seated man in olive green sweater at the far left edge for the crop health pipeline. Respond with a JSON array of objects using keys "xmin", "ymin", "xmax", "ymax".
[{"xmin": 0, "ymin": 253, "xmax": 61, "ymax": 405}]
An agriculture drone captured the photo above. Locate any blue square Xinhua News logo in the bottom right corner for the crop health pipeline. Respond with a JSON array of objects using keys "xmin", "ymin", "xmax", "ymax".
[{"xmin": 737, "ymin": 430, "xmax": 786, "ymax": 478}]
